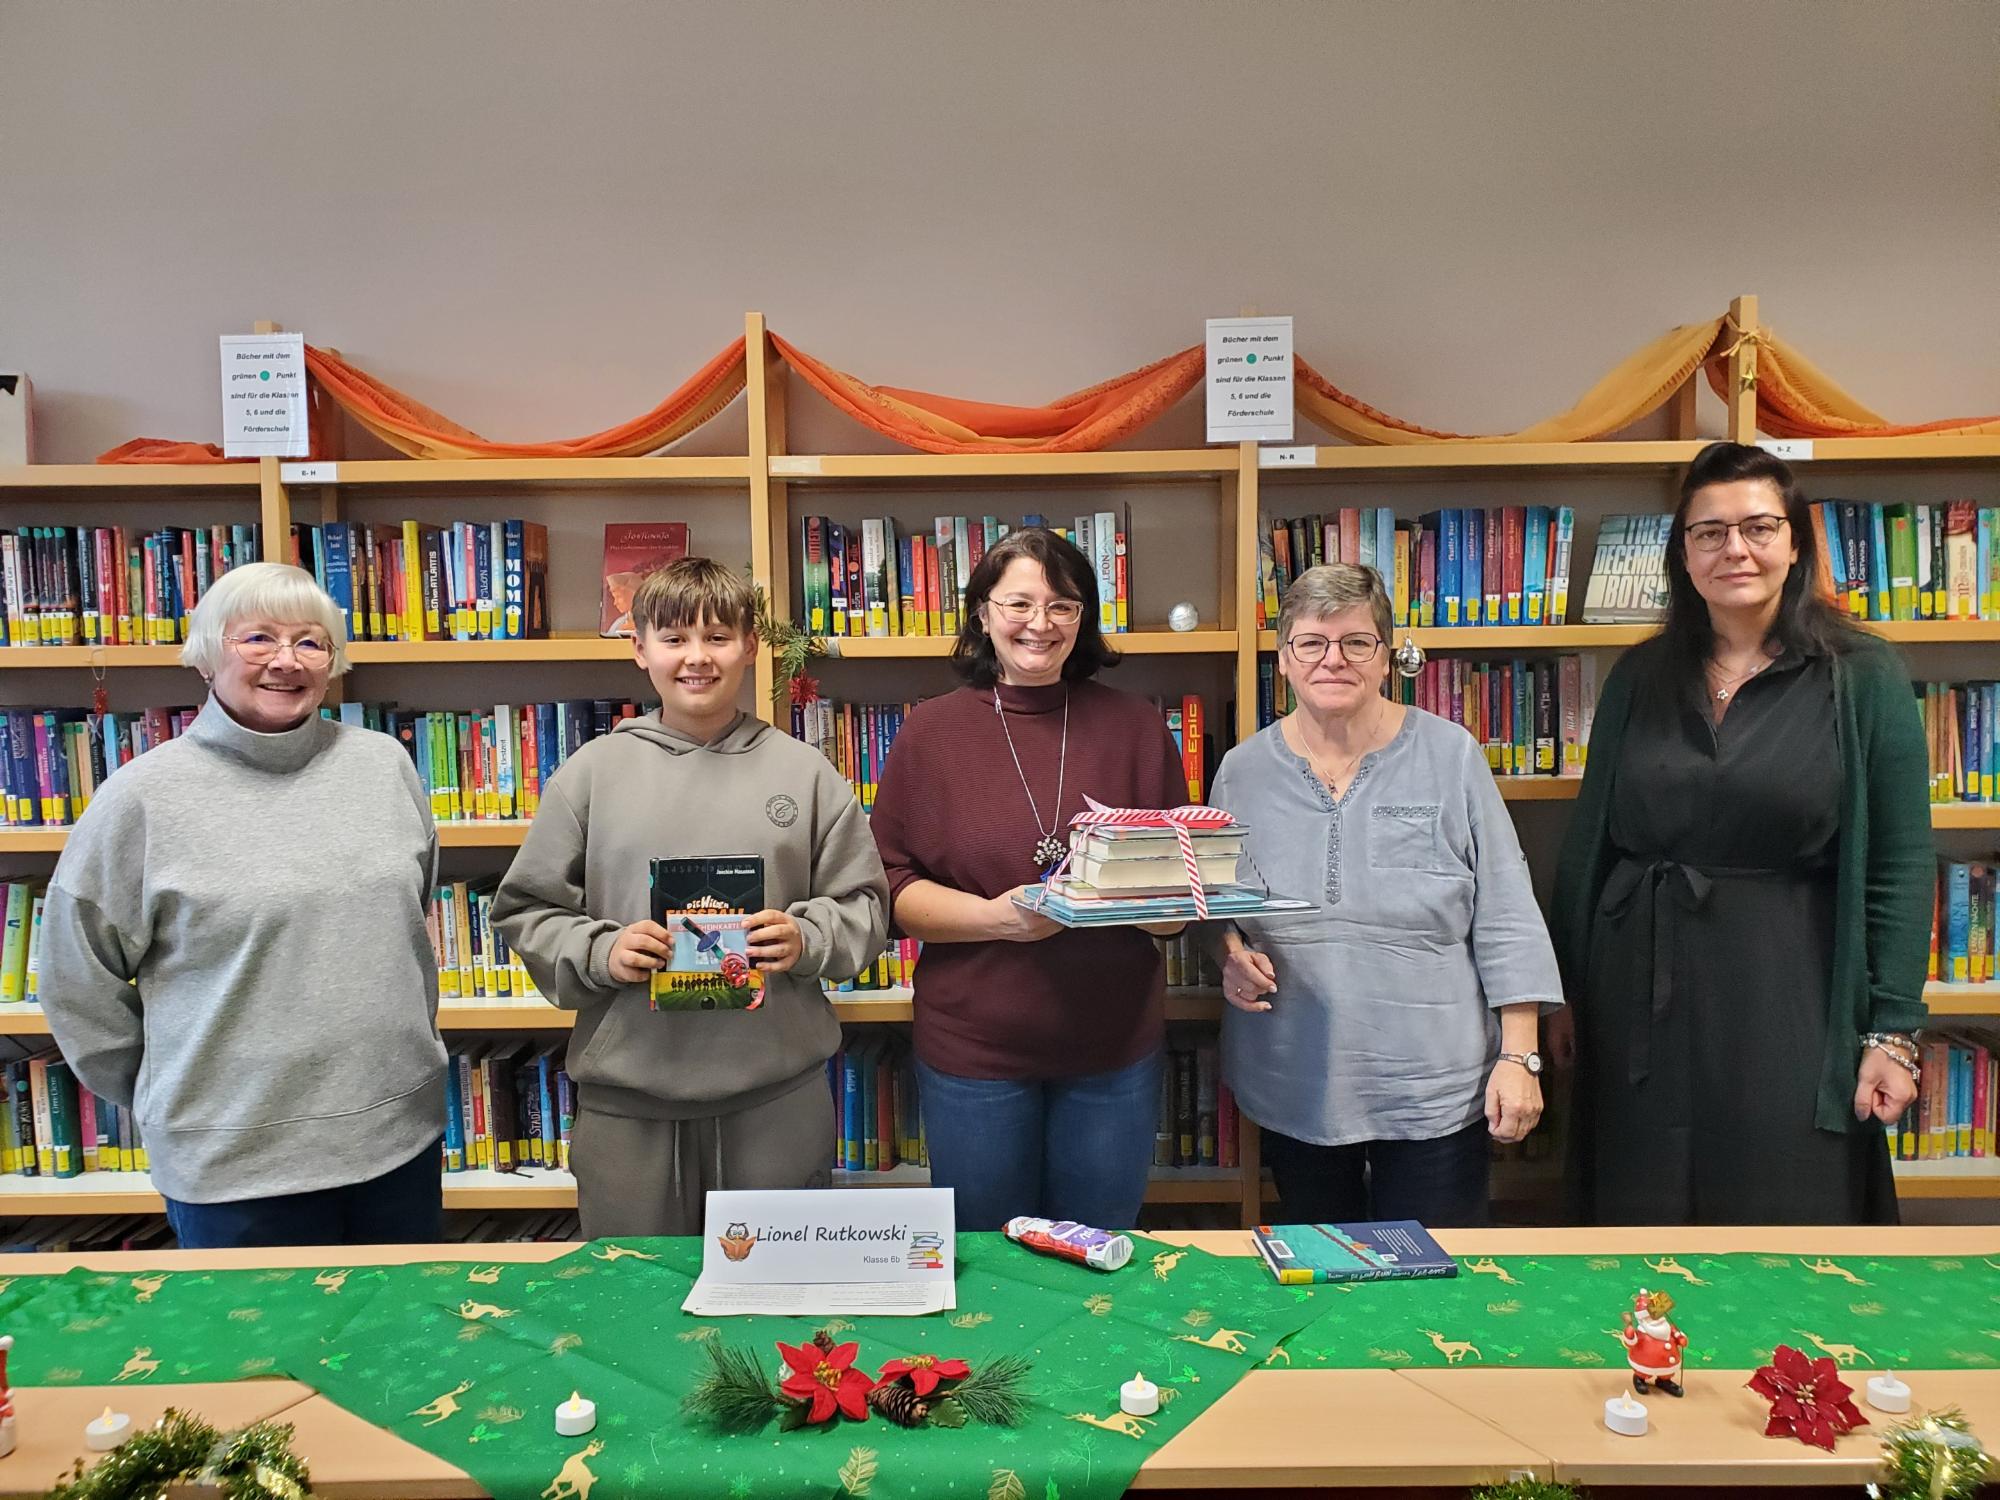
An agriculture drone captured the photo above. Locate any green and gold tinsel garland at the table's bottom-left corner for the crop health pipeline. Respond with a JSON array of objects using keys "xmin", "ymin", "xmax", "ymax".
[{"xmin": 48, "ymin": 1410, "xmax": 312, "ymax": 1500}]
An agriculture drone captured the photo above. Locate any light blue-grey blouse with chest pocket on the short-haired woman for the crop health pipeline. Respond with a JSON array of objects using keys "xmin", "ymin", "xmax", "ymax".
[{"xmin": 1210, "ymin": 708, "xmax": 1562, "ymax": 1146}]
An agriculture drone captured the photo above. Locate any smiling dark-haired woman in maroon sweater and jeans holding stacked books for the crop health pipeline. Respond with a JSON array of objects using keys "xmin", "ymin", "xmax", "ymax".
[{"xmin": 872, "ymin": 528, "xmax": 1188, "ymax": 1230}]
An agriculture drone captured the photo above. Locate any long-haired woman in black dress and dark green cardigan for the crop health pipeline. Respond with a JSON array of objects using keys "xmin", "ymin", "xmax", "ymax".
[{"xmin": 1552, "ymin": 442, "xmax": 1936, "ymax": 1224}]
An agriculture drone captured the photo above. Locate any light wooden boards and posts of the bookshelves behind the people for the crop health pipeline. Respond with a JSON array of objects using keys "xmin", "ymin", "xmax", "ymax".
[{"xmin": 0, "ymin": 300, "xmax": 2000, "ymax": 1224}]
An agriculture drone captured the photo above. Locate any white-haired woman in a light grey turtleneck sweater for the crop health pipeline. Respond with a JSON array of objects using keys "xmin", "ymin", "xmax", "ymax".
[{"xmin": 40, "ymin": 562, "xmax": 444, "ymax": 1248}]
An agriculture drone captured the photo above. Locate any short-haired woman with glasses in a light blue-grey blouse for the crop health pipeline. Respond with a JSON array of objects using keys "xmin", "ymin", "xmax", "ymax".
[{"xmin": 1210, "ymin": 562, "xmax": 1562, "ymax": 1226}]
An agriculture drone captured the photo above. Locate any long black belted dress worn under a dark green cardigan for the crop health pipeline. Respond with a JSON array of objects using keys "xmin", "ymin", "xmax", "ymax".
[{"xmin": 1578, "ymin": 654, "xmax": 1896, "ymax": 1224}]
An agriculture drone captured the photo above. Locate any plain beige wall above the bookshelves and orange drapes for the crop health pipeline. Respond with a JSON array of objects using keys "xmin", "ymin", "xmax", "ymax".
[{"xmin": 0, "ymin": 0, "xmax": 2000, "ymax": 460}]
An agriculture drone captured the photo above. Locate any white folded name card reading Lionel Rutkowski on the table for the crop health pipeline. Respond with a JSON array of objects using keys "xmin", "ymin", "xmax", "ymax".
[{"xmin": 680, "ymin": 1188, "xmax": 958, "ymax": 1318}]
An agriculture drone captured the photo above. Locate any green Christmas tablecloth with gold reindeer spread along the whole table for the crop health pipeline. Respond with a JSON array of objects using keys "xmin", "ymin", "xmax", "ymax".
[{"xmin": 0, "ymin": 1234, "xmax": 2000, "ymax": 1500}]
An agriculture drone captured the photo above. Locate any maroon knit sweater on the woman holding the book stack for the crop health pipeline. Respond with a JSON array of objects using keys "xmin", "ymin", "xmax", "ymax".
[{"xmin": 870, "ymin": 682, "xmax": 1188, "ymax": 1078}]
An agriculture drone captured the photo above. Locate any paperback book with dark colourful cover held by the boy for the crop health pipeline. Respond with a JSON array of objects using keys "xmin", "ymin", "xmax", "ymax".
[{"xmin": 652, "ymin": 854, "xmax": 764, "ymax": 1010}]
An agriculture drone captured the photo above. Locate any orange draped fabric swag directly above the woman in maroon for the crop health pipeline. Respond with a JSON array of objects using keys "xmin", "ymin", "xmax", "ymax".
[{"xmin": 770, "ymin": 334, "xmax": 1204, "ymax": 454}]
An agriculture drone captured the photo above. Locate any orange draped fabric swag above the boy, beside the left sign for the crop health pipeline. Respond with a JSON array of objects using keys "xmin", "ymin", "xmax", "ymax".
[{"xmin": 306, "ymin": 338, "xmax": 744, "ymax": 458}]
